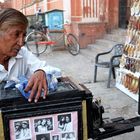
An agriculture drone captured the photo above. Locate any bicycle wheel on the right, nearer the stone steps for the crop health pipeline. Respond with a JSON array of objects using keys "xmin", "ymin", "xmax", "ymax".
[{"xmin": 66, "ymin": 33, "xmax": 80, "ymax": 55}]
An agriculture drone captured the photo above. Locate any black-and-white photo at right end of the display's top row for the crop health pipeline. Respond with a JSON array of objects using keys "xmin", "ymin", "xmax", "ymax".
[{"xmin": 58, "ymin": 114, "xmax": 73, "ymax": 132}]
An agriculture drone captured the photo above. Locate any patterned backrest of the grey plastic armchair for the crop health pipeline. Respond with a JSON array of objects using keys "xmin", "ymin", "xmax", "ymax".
[{"xmin": 113, "ymin": 44, "xmax": 124, "ymax": 65}]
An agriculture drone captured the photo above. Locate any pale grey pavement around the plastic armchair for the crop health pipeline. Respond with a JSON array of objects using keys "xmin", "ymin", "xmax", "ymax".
[{"xmin": 39, "ymin": 44, "xmax": 140, "ymax": 140}]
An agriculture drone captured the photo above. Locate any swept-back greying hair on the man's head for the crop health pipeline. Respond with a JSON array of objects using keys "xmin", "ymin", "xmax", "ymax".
[{"xmin": 0, "ymin": 8, "xmax": 28, "ymax": 30}]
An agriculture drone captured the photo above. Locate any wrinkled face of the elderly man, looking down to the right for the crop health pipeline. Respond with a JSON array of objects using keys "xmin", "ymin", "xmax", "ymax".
[{"xmin": 0, "ymin": 25, "xmax": 26, "ymax": 57}]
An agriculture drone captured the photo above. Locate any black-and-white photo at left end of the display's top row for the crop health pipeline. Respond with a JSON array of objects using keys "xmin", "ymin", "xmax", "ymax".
[{"xmin": 14, "ymin": 120, "xmax": 31, "ymax": 140}]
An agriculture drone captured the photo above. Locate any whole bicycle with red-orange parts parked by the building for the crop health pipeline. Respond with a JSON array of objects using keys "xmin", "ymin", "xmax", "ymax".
[{"xmin": 25, "ymin": 23, "xmax": 80, "ymax": 56}]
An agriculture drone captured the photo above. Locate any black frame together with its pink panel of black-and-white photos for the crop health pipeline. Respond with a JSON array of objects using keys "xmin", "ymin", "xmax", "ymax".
[{"xmin": 5, "ymin": 105, "xmax": 82, "ymax": 140}]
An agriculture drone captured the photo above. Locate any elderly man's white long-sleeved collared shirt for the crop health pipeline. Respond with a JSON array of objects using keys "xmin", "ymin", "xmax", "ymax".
[{"xmin": 0, "ymin": 47, "xmax": 61, "ymax": 81}]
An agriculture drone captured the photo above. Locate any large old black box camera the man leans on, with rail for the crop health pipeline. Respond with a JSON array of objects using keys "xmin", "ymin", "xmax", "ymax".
[{"xmin": 0, "ymin": 77, "xmax": 140, "ymax": 140}]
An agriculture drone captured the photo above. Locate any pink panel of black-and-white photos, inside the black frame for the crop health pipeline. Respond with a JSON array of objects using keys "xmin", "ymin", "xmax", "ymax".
[{"xmin": 9, "ymin": 111, "xmax": 78, "ymax": 140}]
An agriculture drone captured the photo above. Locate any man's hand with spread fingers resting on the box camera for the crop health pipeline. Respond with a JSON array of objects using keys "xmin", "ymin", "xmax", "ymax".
[{"xmin": 24, "ymin": 70, "xmax": 48, "ymax": 102}]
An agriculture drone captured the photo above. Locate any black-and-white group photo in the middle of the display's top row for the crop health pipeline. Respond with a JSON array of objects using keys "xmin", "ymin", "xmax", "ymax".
[{"xmin": 34, "ymin": 117, "xmax": 53, "ymax": 133}]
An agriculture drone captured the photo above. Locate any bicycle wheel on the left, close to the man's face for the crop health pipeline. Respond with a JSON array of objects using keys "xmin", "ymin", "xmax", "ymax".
[{"xmin": 25, "ymin": 31, "xmax": 48, "ymax": 56}]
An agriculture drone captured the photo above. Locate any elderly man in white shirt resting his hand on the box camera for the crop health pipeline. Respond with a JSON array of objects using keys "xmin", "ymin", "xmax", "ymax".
[{"xmin": 0, "ymin": 8, "xmax": 60, "ymax": 102}]
